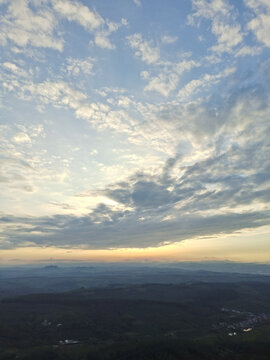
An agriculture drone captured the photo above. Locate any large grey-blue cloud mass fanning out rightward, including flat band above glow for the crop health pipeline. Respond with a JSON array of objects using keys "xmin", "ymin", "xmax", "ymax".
[{"xmin": 1, "ymin": 62, "xmax": 270, "ymax": 249}]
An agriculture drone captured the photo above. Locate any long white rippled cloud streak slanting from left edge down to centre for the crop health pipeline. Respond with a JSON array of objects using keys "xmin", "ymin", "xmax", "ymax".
[{"xmin": 0, "ymin": 67, "xmax": 172, "ymax": 152}]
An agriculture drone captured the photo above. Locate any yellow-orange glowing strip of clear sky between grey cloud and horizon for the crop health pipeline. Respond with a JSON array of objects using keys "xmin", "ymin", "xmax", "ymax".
[{"xmin": 0, "ymin": 227, "xmax": 270, "ymax": 265}]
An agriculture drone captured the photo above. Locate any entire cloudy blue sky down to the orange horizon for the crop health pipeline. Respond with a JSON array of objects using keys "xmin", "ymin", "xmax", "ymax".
[{"xmin": 0, "ymin": 0, "xmax": 270, "ymax": 263}]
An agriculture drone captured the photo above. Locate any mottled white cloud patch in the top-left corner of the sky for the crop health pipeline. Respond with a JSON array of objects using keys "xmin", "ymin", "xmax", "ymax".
[{"xmin": 0, "ymin": 0, "xmax": 127, "ymax": 52}]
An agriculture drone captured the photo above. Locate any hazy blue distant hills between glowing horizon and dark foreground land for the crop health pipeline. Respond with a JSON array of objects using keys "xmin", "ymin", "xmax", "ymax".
[{"xmin": 0, "ymin": 263, "xmax": 270, "ymax": 298}]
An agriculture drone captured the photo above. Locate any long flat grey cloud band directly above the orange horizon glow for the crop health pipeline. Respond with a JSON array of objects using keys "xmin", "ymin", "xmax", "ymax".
[{"xmin": 1, "ymin": 211, "xmax": 270, "ymax": 249}]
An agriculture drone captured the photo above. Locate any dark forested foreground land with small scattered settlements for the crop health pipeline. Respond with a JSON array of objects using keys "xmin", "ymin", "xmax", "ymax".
[{"xmin": 0, "ymin": 281, "xmax": 270, "ymax": 360}]
